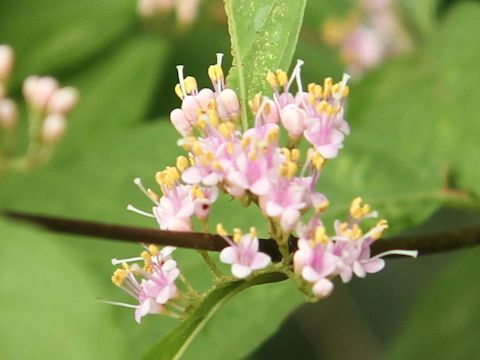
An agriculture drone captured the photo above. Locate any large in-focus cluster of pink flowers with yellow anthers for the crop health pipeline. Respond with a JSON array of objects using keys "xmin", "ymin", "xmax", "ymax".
[{"xmin": 111, "ymin": 54, "xmax": 416, "ymax": 320}]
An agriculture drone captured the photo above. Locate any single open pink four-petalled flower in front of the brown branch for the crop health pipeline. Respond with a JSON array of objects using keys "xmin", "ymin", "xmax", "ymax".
[{"xmin": 220, "ymin": 233, "xmax": 271, "ymax": 279}]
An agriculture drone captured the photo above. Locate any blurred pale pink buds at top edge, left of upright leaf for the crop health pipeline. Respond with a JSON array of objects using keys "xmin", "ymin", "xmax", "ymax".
[{"xmin": 137, "ymin": 0, "xmax": 200, "ymax": 25}]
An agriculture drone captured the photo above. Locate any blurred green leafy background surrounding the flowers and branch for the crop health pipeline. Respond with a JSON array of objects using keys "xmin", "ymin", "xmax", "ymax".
[{"xmin": 0, "ymin": 0, "xmax": 480, "ymax": 359}]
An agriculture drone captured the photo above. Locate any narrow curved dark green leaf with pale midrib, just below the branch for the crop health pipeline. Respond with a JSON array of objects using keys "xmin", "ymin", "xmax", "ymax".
[{"xmin": 144, "ymin": 273, "xmax": 292, "ymax": 360}]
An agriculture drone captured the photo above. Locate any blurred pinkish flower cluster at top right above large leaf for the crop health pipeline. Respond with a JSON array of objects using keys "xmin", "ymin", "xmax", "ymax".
[{"xmin": 323, "ymin": 0, "xmax": 411, "ymax": 77}]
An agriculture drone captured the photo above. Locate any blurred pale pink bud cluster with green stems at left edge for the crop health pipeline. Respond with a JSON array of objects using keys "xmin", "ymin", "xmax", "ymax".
[{"xmin": 0, "ymin": 45, "xmax": 78, "ymax": 172}]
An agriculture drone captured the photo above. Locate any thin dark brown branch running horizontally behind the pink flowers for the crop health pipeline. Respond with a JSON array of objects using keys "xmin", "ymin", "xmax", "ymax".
[{"xmin": 5, "ymin": 211, "xmax": 480, "ymax": 261}]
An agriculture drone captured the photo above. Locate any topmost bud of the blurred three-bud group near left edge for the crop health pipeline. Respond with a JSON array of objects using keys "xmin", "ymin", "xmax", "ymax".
[{"xmin": 23, "ymin": 76, "xmax": 58, "ymax": 111}]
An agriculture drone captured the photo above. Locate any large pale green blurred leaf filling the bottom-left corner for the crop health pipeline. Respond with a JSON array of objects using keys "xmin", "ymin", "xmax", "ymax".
[{"xmin": 0, "ymin": 219, "xmax": 126, "ymax": 360}]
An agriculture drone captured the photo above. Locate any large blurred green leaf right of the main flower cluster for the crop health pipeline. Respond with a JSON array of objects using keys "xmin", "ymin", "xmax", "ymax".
[{"xmin": 312, "ymin": 4, "xmax": 480, "ymax": 231}]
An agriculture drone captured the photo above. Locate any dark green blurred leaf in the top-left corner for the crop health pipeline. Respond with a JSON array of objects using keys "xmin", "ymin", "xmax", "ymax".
[{"xmin": 0, "ymin": 0, "xmax": 137, "ymax": 84}]
